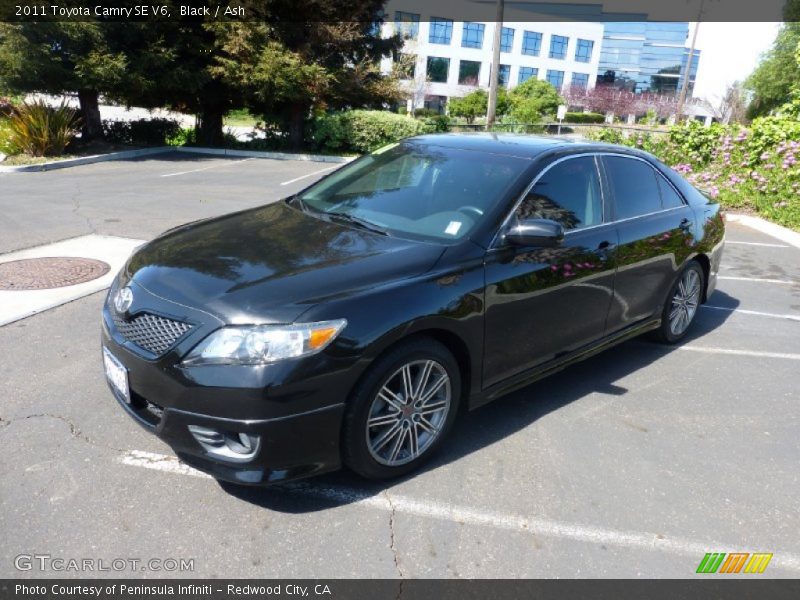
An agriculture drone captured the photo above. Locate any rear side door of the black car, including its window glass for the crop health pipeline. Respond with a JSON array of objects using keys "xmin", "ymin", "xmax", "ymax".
[{"xmin": 602, "ymin": 154, "xmax": 694, "ymax": 332}]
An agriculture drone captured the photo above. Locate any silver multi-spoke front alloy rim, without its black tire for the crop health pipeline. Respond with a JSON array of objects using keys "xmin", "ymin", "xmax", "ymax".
[{"xmin": 366, "ymin": 360, "xmax": 452, "ymax": 467}]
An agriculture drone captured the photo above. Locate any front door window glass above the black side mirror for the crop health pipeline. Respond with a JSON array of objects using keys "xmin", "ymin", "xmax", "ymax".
[{"xmin": 514, "ymin": 156, "xmax": 603, "ymax": 229}]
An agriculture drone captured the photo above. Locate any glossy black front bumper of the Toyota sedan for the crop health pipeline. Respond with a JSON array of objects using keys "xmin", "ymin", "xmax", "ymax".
[{"xmin": 101, "ymin": 282, "xmax": 354, "ymax": 485}]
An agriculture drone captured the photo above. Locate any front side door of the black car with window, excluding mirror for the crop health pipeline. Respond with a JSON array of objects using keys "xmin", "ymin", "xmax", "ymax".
[{"xmin": 484, "ymin": 155, "xmax": 617, "ymax": 387}]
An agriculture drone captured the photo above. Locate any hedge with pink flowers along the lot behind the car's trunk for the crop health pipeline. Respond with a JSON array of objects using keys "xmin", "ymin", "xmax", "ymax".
[{"xmin": 593, "ymin": 114, "xmax": 800, "ymax": 229}]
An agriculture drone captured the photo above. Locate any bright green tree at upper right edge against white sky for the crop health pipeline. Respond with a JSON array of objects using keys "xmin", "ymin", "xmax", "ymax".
[{"xmin": 745, "ymin": 20, "xmax": 800, "ymax": 118}]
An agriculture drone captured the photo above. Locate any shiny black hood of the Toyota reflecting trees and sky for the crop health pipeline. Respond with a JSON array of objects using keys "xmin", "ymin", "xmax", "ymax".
[{"xmin": 126, "ymin": 202, "xmax": 444, "ymax": 323}]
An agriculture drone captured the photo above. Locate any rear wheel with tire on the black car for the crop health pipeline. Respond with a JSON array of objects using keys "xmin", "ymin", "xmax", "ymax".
[{"xmin": 654, "ymin": 260, "xmax": 705, "ymax": 344}]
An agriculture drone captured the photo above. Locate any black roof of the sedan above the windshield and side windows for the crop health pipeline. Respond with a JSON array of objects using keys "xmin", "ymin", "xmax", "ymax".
[{"xmin": 406, "ymin": 132, "xmax": 647, "ymax": 158}]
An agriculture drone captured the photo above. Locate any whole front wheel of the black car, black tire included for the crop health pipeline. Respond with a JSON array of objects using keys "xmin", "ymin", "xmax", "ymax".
[{"xmin": 343, "ymin": 337, "xmax": 461, "ymax": 480}]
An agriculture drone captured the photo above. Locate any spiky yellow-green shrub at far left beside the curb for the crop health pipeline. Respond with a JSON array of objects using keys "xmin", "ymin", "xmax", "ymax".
[{"xmin": 8, "ymin": 100, "xmax": 80, "ymax": 156}]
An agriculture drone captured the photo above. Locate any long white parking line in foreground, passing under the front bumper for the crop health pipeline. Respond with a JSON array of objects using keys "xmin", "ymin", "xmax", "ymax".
[{"xmin": 119, "ymin": 450, "xmax": 800, "ymax": 571}]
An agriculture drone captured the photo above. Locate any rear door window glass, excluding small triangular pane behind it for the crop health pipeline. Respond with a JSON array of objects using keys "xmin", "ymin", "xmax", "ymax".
[{"xmin": 603, "ymin": 156, "xmax": 661, "ymax": 221}]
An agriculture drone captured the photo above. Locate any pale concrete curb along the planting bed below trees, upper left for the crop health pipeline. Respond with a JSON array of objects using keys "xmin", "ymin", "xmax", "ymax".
[{"xmin": 0, "ymin": 146, "xmax": 356, "ymax": 173}]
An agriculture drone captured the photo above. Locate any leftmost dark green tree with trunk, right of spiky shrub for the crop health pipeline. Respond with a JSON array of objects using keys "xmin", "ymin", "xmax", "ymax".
[{"xmin": 0, "ymin": 22, "xmax": 128, "ymax": 140}]
